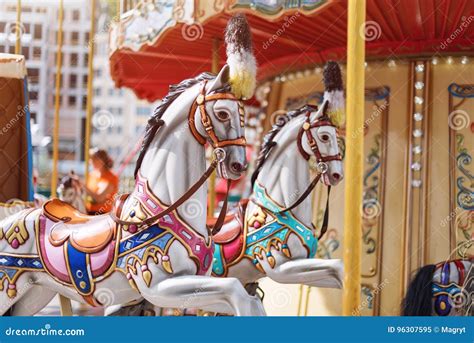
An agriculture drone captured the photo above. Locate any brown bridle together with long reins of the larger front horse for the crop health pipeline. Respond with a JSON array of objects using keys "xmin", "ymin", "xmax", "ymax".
[{"xmin": 110, "ymin": 81, "xmax": 247, "ymax": 235}]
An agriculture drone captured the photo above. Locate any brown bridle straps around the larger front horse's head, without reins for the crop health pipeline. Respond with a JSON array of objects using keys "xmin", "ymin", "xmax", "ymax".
[{"xmin": 188, "ymin": 81, "xmax": 247, "ymax": 149}]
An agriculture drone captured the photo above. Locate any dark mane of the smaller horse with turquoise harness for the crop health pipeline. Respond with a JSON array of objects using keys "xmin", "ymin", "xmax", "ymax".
[{"xmin": 250, "ymin": 105, "xmax": 315, "ymax": 188}]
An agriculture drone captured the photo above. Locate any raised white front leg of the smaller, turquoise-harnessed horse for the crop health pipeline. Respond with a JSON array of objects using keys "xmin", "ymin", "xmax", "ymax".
[{"xmin": 261, "ymin": 258, "xmax": 344, "ymax": 288}]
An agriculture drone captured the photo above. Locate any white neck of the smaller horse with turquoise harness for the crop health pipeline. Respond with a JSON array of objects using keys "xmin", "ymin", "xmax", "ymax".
[{"xmin": 257, "ymin": 120, "xmax": 312, "ymax": 227}]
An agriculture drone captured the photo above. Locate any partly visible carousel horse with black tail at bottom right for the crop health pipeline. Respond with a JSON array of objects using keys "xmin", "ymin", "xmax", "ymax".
[{"xmin": 402, "ymin": 257, "xmax": 474, "ymax": 316}]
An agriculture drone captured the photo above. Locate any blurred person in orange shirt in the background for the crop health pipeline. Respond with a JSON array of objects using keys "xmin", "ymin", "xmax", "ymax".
[{"xmin": 84, "ymin": 149, "xmax": 119, "ymax": 214}]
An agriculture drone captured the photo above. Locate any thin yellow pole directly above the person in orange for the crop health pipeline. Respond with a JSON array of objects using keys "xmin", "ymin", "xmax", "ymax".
[{"xmin": 84, "ymin": 0, "xmax": 95, "ymax": 184}]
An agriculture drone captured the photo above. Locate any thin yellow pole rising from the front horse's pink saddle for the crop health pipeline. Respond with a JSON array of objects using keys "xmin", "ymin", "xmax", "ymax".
[{"xmin": 51, "ymin": 0, "xmax": 72, "ymax": 316}]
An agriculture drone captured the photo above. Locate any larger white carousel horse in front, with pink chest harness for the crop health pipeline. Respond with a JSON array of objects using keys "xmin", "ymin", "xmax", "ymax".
[{"xmin": 0, "ymin": 16, "xmax": 264, "ymax": 315}]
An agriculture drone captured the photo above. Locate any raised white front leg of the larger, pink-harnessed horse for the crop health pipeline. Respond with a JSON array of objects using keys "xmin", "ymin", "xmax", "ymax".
[{"xmin": 134, "ymin": 275, "xmax": 265, "ymax": 316}]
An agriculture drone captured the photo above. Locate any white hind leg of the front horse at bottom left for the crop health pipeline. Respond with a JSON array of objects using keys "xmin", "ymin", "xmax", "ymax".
[{"xmin": 11, "ymin": 286, "xmax": 56, "ymax": 316}]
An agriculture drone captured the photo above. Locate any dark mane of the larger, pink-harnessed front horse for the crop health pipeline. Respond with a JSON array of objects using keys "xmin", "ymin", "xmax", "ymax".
[{"xmin": 134, "ymin": 73, "xmax": 216, "ymax": 178}]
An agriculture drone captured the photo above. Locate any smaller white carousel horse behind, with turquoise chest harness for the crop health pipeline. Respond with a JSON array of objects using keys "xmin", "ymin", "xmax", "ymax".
[{"xmin": 213, "ymin": 62, "xmax": 344, "ymax": 290}]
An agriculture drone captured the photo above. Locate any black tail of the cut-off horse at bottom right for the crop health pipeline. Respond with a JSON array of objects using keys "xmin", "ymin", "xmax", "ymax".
[{"xmin": 402, "ymin": 264, "xmax": 436, "ymax": 316}]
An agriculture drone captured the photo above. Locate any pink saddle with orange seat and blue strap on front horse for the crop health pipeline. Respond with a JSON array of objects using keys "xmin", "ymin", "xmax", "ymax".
[{"xmin": 38, "ymin": 199, "xmax": 117, "ymax": 306}]
